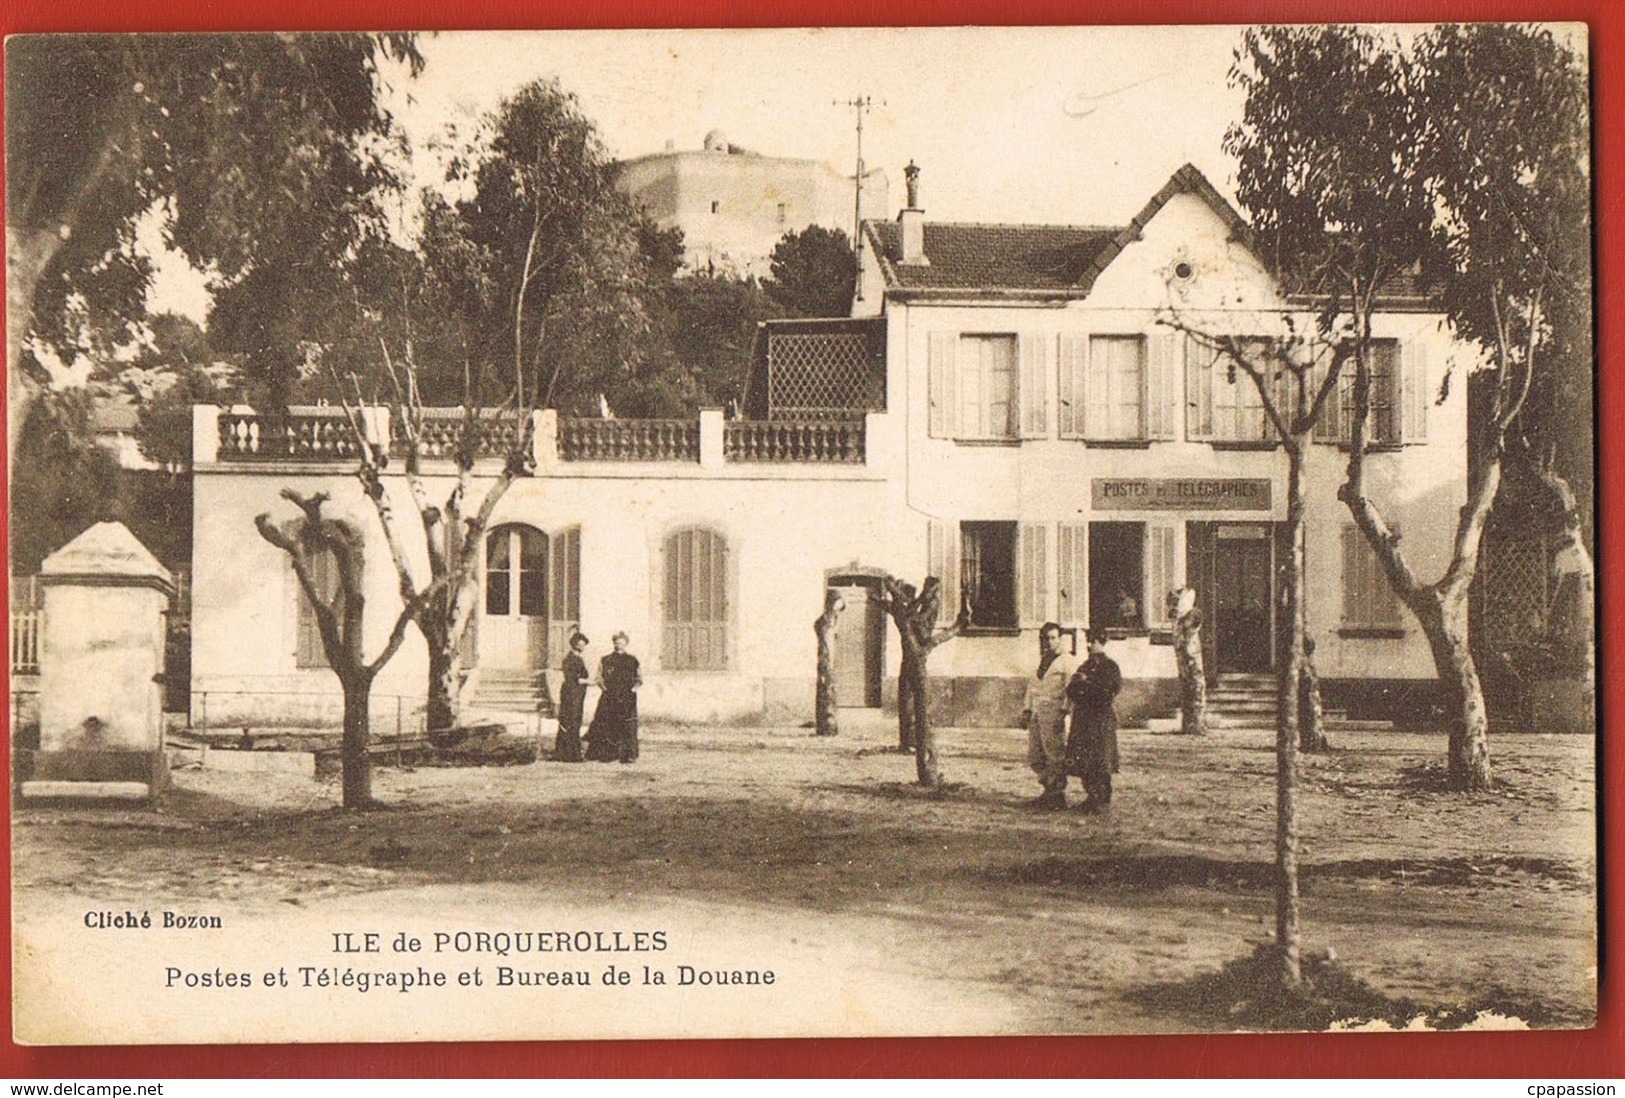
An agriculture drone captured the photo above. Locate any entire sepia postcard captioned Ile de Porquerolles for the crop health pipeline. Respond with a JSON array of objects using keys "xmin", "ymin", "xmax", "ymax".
[{"xmin": 5, "ymin": 23, "xmax": 1601, "ymax": 1046}]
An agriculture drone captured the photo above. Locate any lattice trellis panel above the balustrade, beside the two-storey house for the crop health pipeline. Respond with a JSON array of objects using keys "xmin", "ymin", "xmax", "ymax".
[{"xmin": 767, "ymin": 331, "xmax": 886, "ymax": 419}]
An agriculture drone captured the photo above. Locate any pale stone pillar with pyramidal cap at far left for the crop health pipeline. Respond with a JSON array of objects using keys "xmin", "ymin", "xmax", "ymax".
[{"xmin": 23, "ymin": 523, "xmax": 176, "ymax": 799}]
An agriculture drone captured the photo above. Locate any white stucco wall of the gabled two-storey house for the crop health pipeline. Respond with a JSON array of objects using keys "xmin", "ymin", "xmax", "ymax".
[{"xmin": 887, "ymin": 195, "xmax": 1471, "ymax": 679}]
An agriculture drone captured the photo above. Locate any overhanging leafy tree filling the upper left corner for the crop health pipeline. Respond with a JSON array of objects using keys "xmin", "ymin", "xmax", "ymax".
[{"xmin": 5, "ymin": 34, "xmax": 423, "ymax": 452}]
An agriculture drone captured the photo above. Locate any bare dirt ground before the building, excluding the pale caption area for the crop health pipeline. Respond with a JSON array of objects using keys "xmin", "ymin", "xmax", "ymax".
[{"xmin": 13, "ymin": 715, "xmax": 1597, "ymax": 1033}]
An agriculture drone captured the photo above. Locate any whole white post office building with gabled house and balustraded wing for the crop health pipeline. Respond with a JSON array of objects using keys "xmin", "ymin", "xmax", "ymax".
[{"xmin": 192, "ymin": 167, "xmax": 1467, "ymax": 724}]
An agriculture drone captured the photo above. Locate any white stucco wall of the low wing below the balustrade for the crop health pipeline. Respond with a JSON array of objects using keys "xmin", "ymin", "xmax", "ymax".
[{"xmin": 192, "ymin": 432, "xmax": 900, "ymax": 726}]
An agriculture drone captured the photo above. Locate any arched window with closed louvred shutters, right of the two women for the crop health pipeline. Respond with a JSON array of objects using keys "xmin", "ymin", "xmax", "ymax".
[{"xmin": 660, "ymin": 526, "xmax": 728, "ymax": 671}]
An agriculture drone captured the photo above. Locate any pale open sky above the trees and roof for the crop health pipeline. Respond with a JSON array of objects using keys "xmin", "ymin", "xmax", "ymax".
[{"xmin": 150, "ymin": 28, "xmax": 1242, "ymax": 320}]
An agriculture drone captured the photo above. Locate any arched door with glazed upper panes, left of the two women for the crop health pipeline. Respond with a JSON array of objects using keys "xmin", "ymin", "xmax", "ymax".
[{"xmin": 479, "ymin": 525, "xmax": 548, "ymax": 671}]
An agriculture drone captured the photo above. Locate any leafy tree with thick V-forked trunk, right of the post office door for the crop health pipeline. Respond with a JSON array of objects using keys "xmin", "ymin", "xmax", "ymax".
[{"xmin": 1225, "ymin": 28, "xmax": 1571, "ymax": 789}]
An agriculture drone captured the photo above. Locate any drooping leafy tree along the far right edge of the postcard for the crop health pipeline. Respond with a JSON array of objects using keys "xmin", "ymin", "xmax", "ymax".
[{"xmin": 1417, "ymin": 24, "xmax": 1596, "ymax": 695}]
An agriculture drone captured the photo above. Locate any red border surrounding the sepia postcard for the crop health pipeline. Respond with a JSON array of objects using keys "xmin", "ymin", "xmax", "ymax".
[{"xmin": 0, "ymin": 0, "xmax": 1625, "ymax": 1079}]
